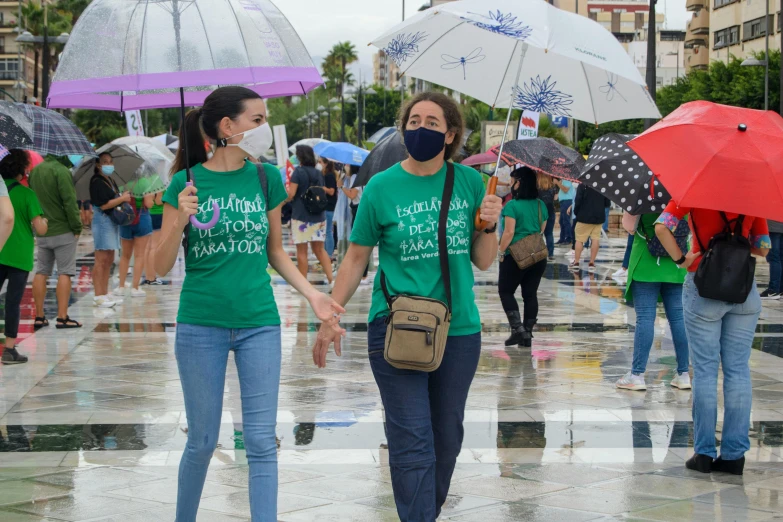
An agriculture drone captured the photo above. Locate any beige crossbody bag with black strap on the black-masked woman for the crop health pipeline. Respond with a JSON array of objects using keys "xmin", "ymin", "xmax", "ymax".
[{"xmin": 381, "ymin": 163, "xmax": 454, "ymax": 372}]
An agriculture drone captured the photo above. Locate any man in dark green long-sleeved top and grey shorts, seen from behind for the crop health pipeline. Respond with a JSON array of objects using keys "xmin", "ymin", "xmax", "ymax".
[{"xmin": 30, "ymin": 159, "xmax": 82, "ymax": 330}]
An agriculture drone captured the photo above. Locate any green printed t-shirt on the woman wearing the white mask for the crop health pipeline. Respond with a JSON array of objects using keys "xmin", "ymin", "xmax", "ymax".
[{"xmin": 163, "ymin": 162, "xmax": 286, "ymax": 328}]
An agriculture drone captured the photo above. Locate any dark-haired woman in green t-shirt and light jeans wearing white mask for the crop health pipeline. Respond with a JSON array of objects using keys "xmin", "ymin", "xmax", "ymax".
[{"xmin": 155, "ymin": 87, "xmax": 344, "ymax": 522}]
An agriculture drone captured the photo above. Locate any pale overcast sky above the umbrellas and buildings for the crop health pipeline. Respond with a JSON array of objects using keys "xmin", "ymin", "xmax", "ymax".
[{"xmin": 273, "ymin": 0, "xmax": 690, "ymax": 82}]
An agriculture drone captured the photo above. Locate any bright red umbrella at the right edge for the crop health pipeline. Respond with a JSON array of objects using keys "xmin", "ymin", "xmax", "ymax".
[{"xmin": 628, "ymin": 101, "xmax": 783, "ymax": 221}]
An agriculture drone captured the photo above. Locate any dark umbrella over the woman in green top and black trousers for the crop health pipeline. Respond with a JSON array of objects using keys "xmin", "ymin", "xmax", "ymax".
[{"xmin": 490, "ymin": 138, "xmax": 585, "ymax": 181}]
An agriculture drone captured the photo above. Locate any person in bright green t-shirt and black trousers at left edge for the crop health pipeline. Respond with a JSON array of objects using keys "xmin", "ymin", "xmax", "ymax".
[{"xmin": 0, "ymin": 149, "xmax": 47, "ymax": 364}]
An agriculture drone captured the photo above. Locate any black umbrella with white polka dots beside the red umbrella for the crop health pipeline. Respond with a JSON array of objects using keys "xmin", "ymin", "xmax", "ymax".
[{"xmin": 579, "ymin": 133, "xmax": 671, "ymax": 215}]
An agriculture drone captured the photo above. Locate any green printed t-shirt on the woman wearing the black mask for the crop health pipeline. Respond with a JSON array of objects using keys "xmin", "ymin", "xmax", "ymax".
[{"xmin": 351, "ymin": 163, "xmax": 484, "ymax": 335}]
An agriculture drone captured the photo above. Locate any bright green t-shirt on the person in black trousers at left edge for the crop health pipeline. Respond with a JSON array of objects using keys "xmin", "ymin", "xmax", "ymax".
[{"xmin": 0, "ymin": 179, "xmax": 43, "ymax": 272}]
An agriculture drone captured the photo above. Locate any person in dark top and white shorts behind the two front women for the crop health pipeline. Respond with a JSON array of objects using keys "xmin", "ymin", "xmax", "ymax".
[{"xmin": 286, "ymin": 145, "xmax": 334, "ymax": 286}]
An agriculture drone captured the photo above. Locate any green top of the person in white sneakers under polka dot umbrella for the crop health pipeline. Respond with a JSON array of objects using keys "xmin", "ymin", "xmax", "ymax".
[{"xmin": 625, "ymin": 214, "xmax": 688, "ymax": 301}]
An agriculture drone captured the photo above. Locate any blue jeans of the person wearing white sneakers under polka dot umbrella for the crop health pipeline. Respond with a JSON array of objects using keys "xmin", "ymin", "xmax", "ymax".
[{"xmin": 631, "ymin": 281, "xmax": 688, "ymax": 375}]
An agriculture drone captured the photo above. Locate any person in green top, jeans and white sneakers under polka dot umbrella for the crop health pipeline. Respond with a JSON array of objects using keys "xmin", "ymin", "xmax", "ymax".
[{"xmin": 615, "ymin": 212, "xmax": 691, "ymax": 391}]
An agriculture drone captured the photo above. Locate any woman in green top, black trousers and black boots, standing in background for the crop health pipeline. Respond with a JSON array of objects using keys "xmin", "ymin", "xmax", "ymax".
[{"xmin": 498, "ymin": 167, "xmax": 549, "ymax": 348}]
